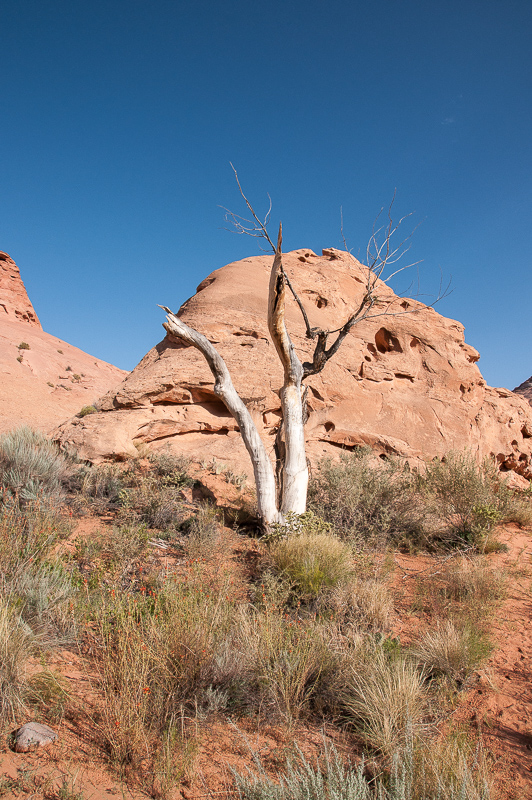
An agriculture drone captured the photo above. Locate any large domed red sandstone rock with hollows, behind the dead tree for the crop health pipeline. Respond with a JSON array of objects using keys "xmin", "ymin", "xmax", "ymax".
[{"xmin": 54, "ymin": 249, "xmax": 532, "ymax": 475}]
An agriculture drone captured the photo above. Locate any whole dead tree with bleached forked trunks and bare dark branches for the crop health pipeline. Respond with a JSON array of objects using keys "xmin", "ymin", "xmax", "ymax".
[{"xmin": 160, "ymin": 178, "xmax": 443, "ymax": 528}]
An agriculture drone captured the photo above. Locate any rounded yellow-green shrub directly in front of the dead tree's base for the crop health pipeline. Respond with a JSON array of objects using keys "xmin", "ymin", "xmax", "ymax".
[{"xmin": 268, "ymin": 529, "xmax": 354, "ymax": 600}]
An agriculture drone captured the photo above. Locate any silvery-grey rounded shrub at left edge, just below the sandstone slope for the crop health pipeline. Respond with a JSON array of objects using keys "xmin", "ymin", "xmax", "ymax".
[{"xmin": 0, "ymin": 426, "xmax": 71, "ymax": 502}]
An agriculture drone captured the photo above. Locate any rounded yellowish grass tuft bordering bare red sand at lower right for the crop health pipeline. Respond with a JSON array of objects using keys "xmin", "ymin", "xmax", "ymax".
[{"xmin": 412, "ymin": 620, "xmax": 492, "ymax": 684}]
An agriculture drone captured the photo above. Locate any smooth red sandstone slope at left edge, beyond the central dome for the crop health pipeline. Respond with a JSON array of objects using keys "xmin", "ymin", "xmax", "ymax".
[{"xmin": 0, "ymin": 253, "xmax": 127, "ymax": 432}]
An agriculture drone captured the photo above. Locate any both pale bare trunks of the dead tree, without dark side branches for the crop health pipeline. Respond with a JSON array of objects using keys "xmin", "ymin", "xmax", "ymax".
[{"xmin": 161, "ymin": 227, "xmax": 308, "ymax": 528}]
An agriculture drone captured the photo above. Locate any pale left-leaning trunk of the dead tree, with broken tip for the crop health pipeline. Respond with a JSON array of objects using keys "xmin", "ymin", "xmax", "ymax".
[{"xmin": 161, "ymin": 306, "xmax": 283, "ymax": 527}]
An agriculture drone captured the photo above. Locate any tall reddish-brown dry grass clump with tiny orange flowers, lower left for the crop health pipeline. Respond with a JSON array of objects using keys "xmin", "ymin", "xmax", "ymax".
[{"xmin": 99, "ymin": 583, "xmax": 234, "ymax": 764}]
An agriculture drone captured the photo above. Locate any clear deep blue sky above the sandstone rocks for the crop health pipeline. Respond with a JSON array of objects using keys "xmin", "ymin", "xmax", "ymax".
[{"xmin": 0, "ymin": 0, "xmax": 532, "ymax": 388}]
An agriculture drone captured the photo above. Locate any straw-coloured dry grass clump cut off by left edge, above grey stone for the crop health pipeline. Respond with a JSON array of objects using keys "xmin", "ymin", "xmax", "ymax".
[{"xmin": 0, "ymin": 596, "xmax": 35, "ymax": 722}]
